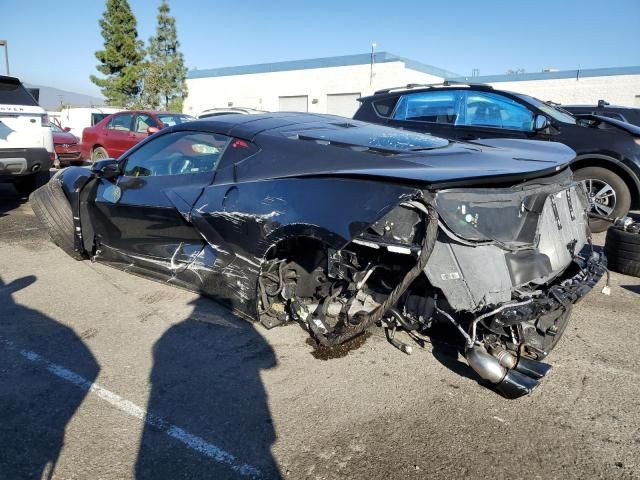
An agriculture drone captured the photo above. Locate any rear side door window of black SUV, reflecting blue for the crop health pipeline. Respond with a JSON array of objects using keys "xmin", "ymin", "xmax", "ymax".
[{"xmin": 393, "ymin": 90, "xmax": 462, "ymax": 125}]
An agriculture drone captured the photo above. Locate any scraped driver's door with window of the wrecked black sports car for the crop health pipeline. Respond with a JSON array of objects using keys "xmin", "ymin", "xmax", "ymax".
[{"xmin": 83, "ymin": 131, "xmax": 229, "ymax": 278}]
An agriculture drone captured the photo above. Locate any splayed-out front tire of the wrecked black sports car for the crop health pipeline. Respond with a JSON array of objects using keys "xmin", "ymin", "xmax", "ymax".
[{"xmin": 29, "ymin": 181, "xmax": 85, "ymax": 260}]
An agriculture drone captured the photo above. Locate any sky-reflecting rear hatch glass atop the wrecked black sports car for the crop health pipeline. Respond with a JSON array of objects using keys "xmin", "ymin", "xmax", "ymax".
[{"xmin": 297, "ymin": 124, "xmax": 449, "ymax": 152}]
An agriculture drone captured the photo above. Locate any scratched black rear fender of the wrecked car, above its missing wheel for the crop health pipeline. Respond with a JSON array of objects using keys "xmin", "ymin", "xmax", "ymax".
[{"xmin": 192, "ymin": 177, "xmax": 420, "ymax": 258}]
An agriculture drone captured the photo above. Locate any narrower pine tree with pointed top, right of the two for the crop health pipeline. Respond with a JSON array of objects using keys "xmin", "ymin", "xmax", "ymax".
[{"xmin": 143, "ymin": 0, "xmax": 187, "ymax": 111}]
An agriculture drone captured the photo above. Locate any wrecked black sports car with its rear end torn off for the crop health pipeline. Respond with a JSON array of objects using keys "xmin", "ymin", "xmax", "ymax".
[{"xmin": 31, "ymin": 114, "xmax": 604, "ymax": 397}]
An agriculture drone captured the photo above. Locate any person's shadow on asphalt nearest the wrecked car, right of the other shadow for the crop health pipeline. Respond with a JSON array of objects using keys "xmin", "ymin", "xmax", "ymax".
[{"xmin": 136, "ymin": 298, "xmax": 280, "ymax": 480}]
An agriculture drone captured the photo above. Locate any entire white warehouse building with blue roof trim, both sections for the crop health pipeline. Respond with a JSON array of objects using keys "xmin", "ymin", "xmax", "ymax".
[{"xmin": 184, "ymin": 52, "xmax": 640, "ymax": 117}]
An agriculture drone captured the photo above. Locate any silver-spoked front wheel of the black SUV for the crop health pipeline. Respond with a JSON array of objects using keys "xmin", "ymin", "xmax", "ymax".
[{"xmin": 574, "ymin": 167, "xmax": 631, "ymax": 233}]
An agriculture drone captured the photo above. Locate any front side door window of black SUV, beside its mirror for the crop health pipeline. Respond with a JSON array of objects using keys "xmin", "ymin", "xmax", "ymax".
[{"xmin": 458, "ymin": 91, "xmax": 533, "ymax": 132}]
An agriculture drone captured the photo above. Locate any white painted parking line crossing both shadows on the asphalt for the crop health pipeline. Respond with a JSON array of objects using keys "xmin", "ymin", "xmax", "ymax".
[{"xmin": 0, "ymin": 336, "xmax": 262, "ymax": 478}]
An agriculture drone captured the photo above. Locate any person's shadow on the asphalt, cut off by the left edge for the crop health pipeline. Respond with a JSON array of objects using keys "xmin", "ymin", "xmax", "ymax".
[{"xmin": 0, "ymin": 275, "xmax": 100, "ymax": 479}]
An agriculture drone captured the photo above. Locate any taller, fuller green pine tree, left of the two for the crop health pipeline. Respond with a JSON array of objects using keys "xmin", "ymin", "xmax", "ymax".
[{"xmin": 90, "ymin": 0, "xmax": 144, "ymax": 107}]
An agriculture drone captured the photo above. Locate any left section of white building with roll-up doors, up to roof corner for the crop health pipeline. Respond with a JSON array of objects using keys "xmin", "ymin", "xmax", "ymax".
[{"xmin": 183, "ymin": 52, "xmax": 456, "ymax": 117}]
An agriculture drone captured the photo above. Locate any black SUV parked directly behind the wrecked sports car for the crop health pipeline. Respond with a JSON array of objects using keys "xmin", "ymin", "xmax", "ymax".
[{"xmin": 354, "ymin": 82, "xmax": 640, "ymax": 232}]
